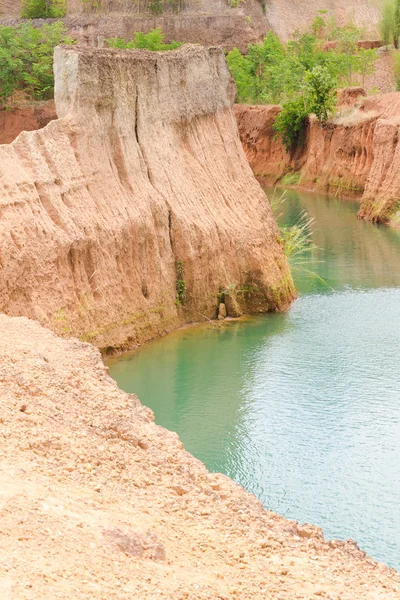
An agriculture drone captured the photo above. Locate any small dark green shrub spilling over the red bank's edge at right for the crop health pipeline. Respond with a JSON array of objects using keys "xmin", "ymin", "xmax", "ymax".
[{"xmin": 273, "ymin": 96, "xmax": 308, "ymax": 152}]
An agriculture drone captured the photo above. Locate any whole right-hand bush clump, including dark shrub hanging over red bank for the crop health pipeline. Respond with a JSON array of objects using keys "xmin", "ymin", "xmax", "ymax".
[{"xmin": 227, "ymin": 14, "xmax": 376, "ymax": 150}]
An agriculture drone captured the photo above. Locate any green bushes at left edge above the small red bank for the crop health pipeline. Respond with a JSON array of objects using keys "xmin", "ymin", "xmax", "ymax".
[{"xmin": 0, "ymin": 21, "xmax": 72, "ymax": 105}]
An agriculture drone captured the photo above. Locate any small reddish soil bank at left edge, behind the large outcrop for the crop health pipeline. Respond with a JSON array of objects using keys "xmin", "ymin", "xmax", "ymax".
[{"xmin": 0, "ymin": 100, "xmax": 57, "ymax": 144}]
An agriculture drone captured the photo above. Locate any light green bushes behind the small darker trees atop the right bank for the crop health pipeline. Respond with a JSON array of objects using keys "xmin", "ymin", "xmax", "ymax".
[{"xmin": 227, "ymin": 15, "xmax": 376, "ymax": 104}]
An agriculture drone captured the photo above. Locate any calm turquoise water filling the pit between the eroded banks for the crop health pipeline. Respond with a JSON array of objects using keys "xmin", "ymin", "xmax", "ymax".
[{"xmin": 109, "ymin": 191, "xmax": 400, "ymax": 569}]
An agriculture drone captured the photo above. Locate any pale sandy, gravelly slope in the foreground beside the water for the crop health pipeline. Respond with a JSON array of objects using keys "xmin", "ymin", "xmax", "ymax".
[{"xmin": 0, "ymin": 315, "xmax": 400, "ymax": 600}]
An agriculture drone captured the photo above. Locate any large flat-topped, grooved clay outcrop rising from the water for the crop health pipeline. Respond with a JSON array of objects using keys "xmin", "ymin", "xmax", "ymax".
[{"xmin": 0, "ymin": 46, "xmax": 293, "ymax": 348}]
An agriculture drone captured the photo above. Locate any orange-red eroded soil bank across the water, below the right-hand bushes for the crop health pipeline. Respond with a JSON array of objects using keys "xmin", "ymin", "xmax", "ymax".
[{"xmin": 235, "ymin": 93, "xmax": 400, "ymax": 226}]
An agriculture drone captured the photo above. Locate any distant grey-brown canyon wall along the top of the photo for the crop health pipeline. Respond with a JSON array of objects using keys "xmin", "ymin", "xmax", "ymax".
[{"xmin": 0, "ymin": 0, "xmax": 380, "ymax": 51}]
